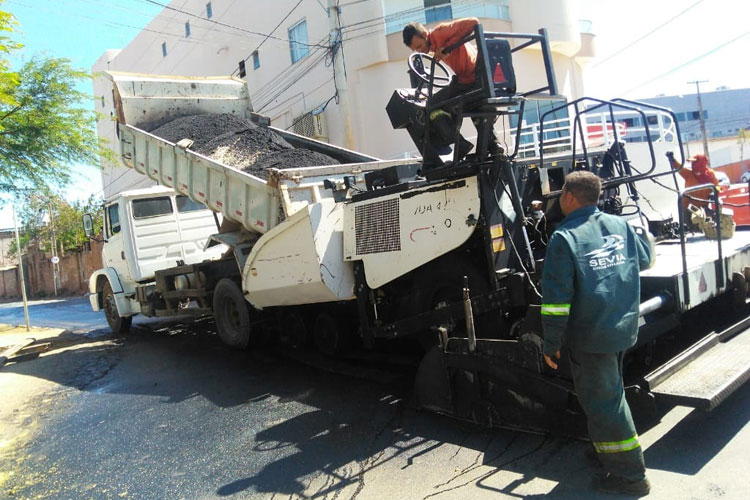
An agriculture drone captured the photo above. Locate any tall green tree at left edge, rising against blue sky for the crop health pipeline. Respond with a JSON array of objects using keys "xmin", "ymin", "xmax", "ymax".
[{"xmin": 0, "ymin": 0, "xmax": 112, "ymax": 193}]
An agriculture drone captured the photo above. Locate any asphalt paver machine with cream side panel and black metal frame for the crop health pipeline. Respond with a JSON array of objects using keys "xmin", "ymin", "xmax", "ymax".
[{"xmin": 352, "ymin": 25, "xmax": 750, "ymax": 434}]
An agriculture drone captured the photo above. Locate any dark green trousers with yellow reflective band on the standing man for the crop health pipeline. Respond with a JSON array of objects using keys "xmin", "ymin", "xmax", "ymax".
[{"xmin": 570, "ymin": 349, "xmax": 646, "ymax": 481}]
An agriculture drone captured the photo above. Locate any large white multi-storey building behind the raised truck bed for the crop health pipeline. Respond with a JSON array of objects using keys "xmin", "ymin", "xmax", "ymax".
[{"xmin": 92, "ymin": 0, "xmax": 594, "ymax": 196}]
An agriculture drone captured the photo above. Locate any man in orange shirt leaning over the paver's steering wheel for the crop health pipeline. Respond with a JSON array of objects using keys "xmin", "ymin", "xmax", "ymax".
[{"xmin": 403, "ymin": 17, "xmax": 503, "ymax": 165}]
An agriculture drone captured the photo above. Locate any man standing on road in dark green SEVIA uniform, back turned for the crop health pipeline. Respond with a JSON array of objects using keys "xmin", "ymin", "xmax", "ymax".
[{"xmin": 541, "ymin": 171, "xmax": 653, "ymax": 495}]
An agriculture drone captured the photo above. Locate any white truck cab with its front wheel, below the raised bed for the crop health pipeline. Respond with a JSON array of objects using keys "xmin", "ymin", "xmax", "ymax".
[{"xmin": 89, "ymin": 186, "xmax": 226, "ymax": 332}]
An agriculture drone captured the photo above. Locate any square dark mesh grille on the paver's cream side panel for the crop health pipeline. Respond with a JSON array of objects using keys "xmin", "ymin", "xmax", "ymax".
[{"xmin": 354, "ymin": 198, "xmax": 401, "ymax": 255}]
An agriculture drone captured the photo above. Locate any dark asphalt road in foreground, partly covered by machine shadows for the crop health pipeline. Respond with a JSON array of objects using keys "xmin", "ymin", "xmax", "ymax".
[{"xmin": 0, "ymin": 299, "xmax": 750, "ymax": 500}]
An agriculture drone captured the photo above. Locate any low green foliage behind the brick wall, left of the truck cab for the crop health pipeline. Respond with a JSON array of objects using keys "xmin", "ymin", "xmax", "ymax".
[{"xmin": 9, "ymin": 194, "xmax": 104, "ymax": 254}]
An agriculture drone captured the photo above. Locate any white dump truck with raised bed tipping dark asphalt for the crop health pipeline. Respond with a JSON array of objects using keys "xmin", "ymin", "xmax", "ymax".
[{"xmin": 87, "ymin": 73, "xmax": 417, "ymax": 347}]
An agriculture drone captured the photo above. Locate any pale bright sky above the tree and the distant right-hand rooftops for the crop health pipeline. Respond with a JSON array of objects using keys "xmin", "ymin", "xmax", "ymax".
[{"xmin": 0, "ymin": 0, "xmax": 750, "ymax": 227}]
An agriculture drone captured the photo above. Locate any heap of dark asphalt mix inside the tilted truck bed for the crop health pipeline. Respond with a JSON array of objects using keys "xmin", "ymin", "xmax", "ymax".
[{"xmin": 151, "ymin": 113, "xmax": 339, "ymax": 179}]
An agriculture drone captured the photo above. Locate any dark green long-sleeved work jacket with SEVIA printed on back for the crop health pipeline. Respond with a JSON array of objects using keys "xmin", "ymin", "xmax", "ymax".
[{"xmin": 542, "ymin": 205, "xmax": 652, "ymax": 356}]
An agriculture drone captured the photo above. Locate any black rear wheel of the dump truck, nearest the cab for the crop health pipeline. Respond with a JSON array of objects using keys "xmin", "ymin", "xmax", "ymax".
[{"xmin": 213, "ymin": 278, "xmax": 250, "ymax": 349}]
